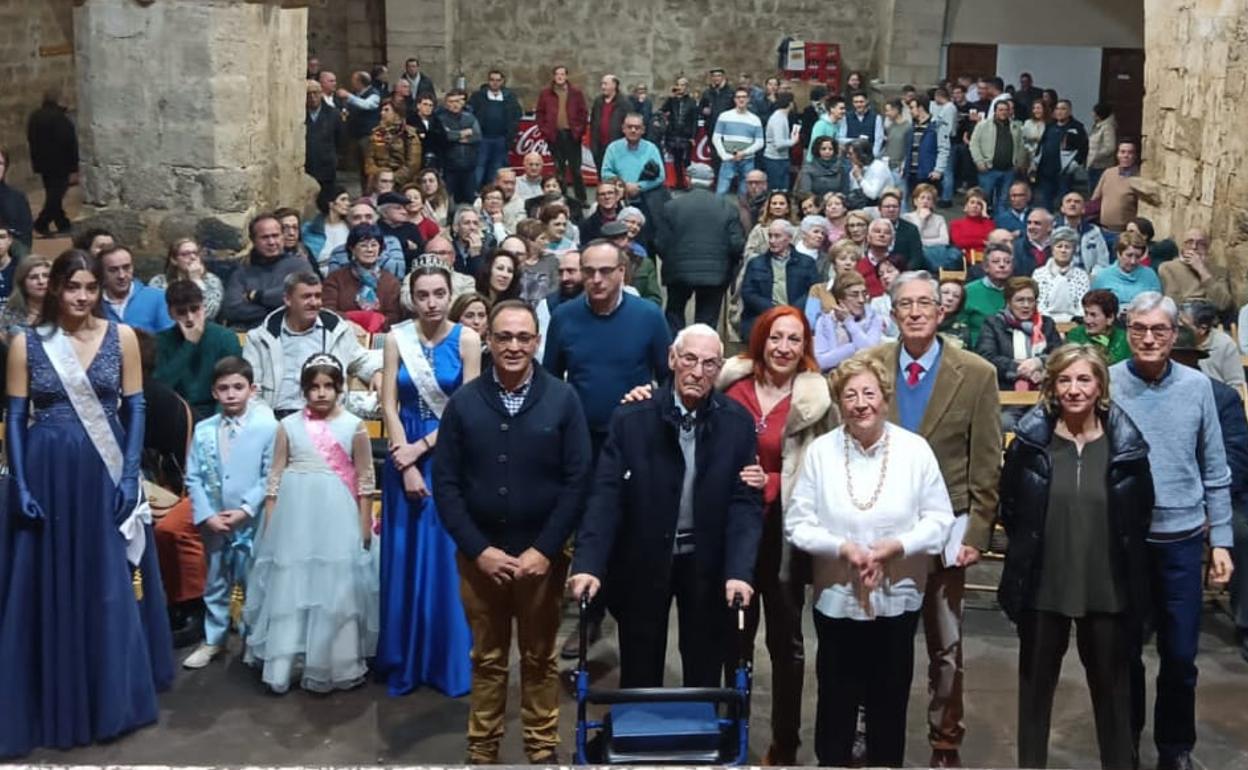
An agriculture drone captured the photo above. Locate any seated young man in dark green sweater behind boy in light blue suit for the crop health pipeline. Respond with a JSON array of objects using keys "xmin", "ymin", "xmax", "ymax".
[{"xmin": 152, "ymin": 281, "xmax": 242, "ymax": 421}]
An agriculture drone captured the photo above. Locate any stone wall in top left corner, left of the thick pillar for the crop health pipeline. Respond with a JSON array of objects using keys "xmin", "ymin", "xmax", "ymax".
[{"xmin": 0, "ymin": 0, "xmax": 74, "ymax": 187}]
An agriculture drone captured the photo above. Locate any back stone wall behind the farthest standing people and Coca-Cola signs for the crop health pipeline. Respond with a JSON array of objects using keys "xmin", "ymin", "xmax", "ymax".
[{"xmin": 386, "ymin": 0, "xmax": 883, "ymax": 107}]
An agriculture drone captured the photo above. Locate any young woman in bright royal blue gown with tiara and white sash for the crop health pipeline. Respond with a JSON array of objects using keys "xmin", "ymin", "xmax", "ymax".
[{"xmin": 377, "ymin": 260, "xmax": 480, "ymax": 696}]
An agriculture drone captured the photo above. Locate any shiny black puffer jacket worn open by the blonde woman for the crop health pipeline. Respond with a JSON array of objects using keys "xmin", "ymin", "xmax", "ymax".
[{"xmin": 997, "ymin": 404, "xmax": 1153, "ymax": 623}]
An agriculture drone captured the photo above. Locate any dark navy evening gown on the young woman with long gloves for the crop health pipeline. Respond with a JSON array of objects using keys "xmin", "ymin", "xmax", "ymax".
[{"xmin": 0, "ymin": 323, "xmax": 173, "ymax": 756}]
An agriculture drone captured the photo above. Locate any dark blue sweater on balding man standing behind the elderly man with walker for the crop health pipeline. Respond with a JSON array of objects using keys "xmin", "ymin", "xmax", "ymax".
[{"xmin": 542, "ymin": 293, "xmax": 671, "ymax": 433}]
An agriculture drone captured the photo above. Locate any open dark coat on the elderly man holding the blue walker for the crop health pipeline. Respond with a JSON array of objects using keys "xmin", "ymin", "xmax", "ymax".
[{"xmin": 572, "ymin": 387, "xmax": 763, "ymax": 614}]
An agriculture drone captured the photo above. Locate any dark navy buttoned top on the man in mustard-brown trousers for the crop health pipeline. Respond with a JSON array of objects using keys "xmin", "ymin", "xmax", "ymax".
[{"xmin": 433, "ymin": 364, "xmax": 590, "ymax": 559}]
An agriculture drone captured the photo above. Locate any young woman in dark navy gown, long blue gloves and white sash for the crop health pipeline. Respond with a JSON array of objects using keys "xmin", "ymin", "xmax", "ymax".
[{"xmin": 0, "ymin": 251, "xmax": 173, "ymax": 758}]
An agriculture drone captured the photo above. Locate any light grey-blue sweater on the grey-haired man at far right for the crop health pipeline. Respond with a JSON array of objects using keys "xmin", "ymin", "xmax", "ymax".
[{"xmin": 1109, "ymin": 359, "xmax": 1232, "ymax": 548}]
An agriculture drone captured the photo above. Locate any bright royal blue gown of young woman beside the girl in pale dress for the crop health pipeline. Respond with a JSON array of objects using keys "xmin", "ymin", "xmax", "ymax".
[{"xmin": 377, "ymin": 324, "xmax": 472, "ymax": 698}]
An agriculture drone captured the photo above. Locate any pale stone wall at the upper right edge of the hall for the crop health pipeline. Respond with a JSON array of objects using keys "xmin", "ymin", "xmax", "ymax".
[{"xmin": 1141, "ymin": 0, "xmax": 1248, "ymax": 293}]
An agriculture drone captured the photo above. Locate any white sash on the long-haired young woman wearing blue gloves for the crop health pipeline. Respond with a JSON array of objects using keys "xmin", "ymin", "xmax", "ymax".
[{"xmin": 39, "ymin": 326, "xmax": 152, "ymax": 564}]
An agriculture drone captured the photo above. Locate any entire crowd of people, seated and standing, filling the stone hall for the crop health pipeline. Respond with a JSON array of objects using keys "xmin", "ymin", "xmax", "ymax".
[{"xmin": 0, "ymin": 52, "xmax": 1248, "ymax": 769}]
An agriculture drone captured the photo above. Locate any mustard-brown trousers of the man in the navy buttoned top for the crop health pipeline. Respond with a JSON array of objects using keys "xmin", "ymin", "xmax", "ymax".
[{"xmin": 457, "ymin": 554, "xmax": 568, "ymax": 764}]
